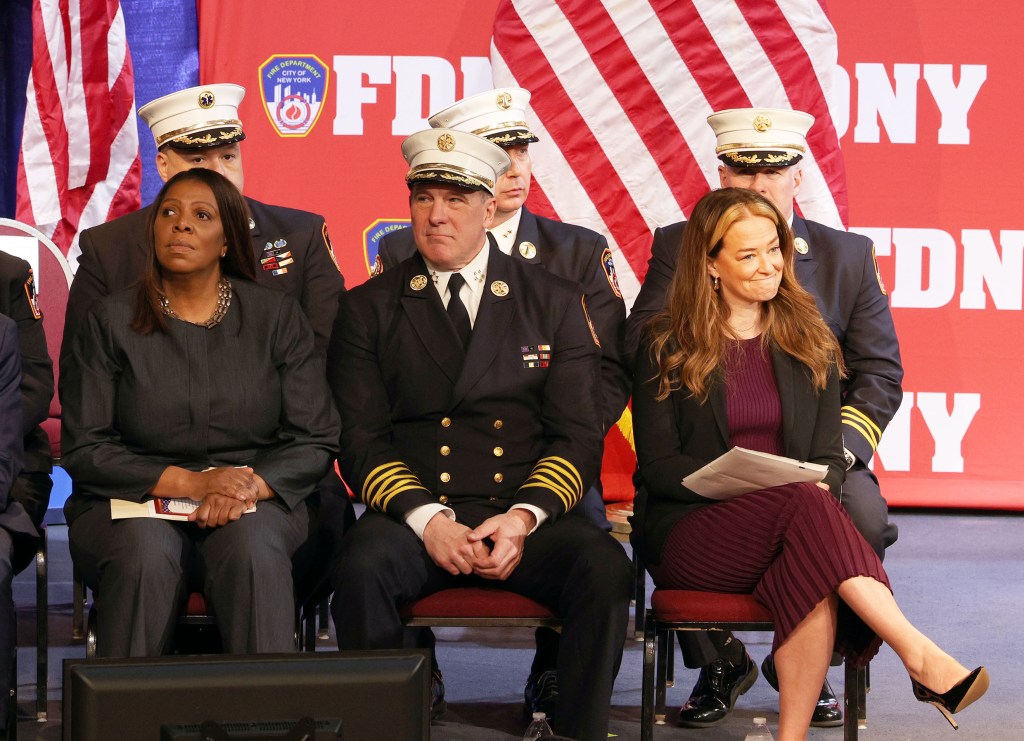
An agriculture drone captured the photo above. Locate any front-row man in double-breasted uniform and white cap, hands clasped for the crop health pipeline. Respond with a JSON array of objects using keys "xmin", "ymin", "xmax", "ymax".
[{"xmin": 328, "ymin": 129, "xmax": 632, "ymax": 741}]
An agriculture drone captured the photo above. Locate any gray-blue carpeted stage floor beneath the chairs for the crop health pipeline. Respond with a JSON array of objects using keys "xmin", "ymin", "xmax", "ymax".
[{"xmin": 14, "ymin": 513, "xmax": 1024, "ymax": 741}]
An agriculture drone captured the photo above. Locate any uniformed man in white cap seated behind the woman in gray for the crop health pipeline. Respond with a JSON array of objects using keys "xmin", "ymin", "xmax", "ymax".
[{"xmin": 60, "ymin": 84, "xmax": 355, "ymax": 609}]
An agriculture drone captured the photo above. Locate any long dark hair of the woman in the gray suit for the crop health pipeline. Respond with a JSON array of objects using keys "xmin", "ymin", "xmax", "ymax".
[{"xmin": 131, "ymin": 168, "xmax": 256, "ymax": 335}]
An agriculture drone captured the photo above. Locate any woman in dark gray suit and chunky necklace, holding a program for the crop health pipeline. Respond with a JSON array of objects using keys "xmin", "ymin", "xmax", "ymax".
[{"xmin": 61, "ymin": 169, "xmax": 339, "ymax": 656}]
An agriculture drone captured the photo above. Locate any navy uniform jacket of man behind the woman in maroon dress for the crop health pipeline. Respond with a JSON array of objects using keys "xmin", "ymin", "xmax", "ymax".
[{"xmin": 626, "ymin": 216, "xmax": 903, "ymax": 464}]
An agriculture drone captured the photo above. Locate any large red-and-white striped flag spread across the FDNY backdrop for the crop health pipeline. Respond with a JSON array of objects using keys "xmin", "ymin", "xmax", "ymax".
[{"xmin": 490, "ymin": 0, "xmax": 847, "ymax": 305}]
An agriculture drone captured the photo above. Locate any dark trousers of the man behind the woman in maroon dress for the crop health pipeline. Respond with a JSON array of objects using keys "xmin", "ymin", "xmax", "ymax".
[{"xmin": 679, "ymin": 461, "xmax": 899, "ymax": 669}]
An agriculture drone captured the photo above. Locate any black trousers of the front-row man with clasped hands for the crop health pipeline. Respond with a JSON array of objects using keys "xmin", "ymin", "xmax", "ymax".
[{"xmin": 332, "ymin": 512, "xmax": 632, "ymax": 741}]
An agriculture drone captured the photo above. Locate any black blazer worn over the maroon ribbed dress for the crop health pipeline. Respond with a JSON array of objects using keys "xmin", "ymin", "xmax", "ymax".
[{"xmin": 633, "ymin": 348, "xmax": 846, "ymax": 563}]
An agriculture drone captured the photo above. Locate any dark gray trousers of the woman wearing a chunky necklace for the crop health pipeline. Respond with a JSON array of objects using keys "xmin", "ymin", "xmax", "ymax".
[{"xmin": 69, "ymin": 499, "xmax": 310, "ymax": 657}]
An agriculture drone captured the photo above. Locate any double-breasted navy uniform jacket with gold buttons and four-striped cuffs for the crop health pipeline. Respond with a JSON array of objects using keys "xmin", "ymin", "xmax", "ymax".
[{"xmin": 328, "ymin": 247, "xmax": 602, "ymax": 527}]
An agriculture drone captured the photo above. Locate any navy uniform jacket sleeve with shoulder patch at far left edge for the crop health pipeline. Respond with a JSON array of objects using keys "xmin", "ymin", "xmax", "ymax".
[{"xmin": 0, "ymin": 252, "xmax": 53, "ymax": 474}]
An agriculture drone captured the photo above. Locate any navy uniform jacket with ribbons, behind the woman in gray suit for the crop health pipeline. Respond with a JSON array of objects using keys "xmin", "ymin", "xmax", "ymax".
[{"xmin": 60, "ymin": 198, "xmax": 345, "ymax": 376}]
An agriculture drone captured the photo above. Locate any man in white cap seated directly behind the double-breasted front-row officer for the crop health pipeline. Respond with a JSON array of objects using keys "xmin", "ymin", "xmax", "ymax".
[{"xmin": 375, "ymin": 88, "xmax": 631, "ymax": 716}]
